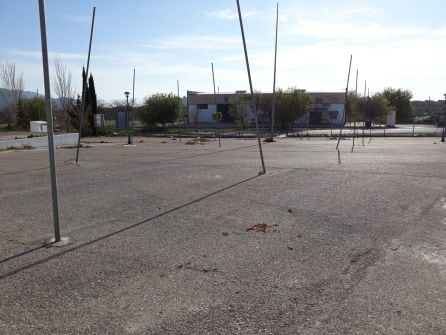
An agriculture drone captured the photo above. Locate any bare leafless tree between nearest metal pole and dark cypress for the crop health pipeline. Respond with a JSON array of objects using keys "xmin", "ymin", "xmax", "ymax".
[{"xmin": 54, "ymin": 57, "xmax": 75, "ymax": 129}]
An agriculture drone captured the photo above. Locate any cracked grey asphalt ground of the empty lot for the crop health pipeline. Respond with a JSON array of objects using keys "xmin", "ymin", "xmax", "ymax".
[{"xmin": 0, "ymin": 138, "xmax": 446, "ymax": 334}]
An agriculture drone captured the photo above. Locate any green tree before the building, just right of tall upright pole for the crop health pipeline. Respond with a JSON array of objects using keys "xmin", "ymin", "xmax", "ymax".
[{"xmin": 275, "ymin": 88, "xmax": 313, "ymax": 132}]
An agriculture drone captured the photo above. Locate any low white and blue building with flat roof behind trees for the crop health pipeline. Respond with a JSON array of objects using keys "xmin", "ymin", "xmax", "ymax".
[{"xmin": 187, "ymin": 91, "xmax": 345, "ymax": 126}]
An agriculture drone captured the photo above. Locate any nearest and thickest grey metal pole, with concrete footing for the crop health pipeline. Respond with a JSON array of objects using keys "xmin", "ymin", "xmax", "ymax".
[{"xmin": 39, "ymin": 0, "xmax": 60, "ymax": 242}]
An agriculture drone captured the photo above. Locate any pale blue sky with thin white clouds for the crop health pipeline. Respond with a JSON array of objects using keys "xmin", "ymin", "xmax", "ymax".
[{"xmin": 0, "ymin": 0, "xmax": 446, "ymax": 102}]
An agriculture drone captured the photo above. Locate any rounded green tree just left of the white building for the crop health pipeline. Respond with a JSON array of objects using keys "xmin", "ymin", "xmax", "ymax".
[{"xmin": 139, "ymin": 93, "xmax": 181, "ymax": 127}]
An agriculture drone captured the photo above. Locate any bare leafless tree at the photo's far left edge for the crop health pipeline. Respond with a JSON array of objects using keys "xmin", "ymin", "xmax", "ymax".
[{"xmin": 0, "ymin": 62, "xmax": 25, "ymax": 128}]
